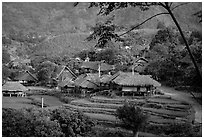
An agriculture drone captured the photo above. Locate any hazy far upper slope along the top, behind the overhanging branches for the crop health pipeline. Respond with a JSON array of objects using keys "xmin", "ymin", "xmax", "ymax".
[{"xmin": 2, "ymin": 2, "xmax": 202, "ymax": 34}]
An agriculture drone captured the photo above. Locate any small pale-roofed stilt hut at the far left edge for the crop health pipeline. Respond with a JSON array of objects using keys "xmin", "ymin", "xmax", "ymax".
[{"xmin": 2, "ymin": 81, "xmax": 28, "ymax": 97}]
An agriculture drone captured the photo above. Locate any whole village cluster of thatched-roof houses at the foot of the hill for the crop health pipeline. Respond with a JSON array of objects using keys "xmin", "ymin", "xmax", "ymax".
[{"xmin": 2, "ymin": 54, "xmax": 161, "ymax": 96}]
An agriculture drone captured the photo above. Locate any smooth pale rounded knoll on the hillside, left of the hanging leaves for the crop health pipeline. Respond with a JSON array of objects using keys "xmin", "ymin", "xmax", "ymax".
[{"xmin": 34, "ymin": 33, "xmax": 96, "ymax": 57}]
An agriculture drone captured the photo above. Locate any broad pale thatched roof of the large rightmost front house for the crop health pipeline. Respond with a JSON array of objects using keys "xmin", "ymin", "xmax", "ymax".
[{"xmin": 117, "ymin": 74, "xmax": 161, "ymax": 86}]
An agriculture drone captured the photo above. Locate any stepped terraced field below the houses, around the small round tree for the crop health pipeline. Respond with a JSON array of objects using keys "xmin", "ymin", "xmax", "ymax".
[{"xmin": 64, "ymin": 96, "xmax": 194, "ymax": 124}]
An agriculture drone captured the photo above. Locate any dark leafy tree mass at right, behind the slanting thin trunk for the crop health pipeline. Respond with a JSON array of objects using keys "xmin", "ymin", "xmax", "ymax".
[{"xmin": 145, "ymin": 28, "xmax": 202, "ymax": 86}]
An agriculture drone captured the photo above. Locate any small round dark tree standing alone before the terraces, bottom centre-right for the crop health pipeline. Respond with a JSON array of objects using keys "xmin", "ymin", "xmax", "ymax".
[{"xmin": 116, "ymin": 103, "xmax": 148, "ymax": 136}]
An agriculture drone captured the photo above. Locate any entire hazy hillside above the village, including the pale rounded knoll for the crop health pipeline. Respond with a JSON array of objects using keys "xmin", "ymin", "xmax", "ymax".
[{"xmin": 2, "ymin": 2, "xmax": 202, "ymax": 59}]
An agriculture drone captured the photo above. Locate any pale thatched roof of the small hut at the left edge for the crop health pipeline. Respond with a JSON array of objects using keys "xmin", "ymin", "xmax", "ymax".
[{"xmin": 2, "ymin": 81, "xmax": 28, "ymax": 91}]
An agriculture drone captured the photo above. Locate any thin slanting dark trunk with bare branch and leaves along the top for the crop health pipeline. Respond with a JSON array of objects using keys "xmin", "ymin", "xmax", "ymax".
[{"xmin": 84, "ymin": 2, "xmax": 202, "ymax": 78}]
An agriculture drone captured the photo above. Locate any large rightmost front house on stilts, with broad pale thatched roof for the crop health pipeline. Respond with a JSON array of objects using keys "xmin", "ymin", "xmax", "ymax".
[{"xmin": 109, "ymin": 72, "xmax": 161, "ymax": 95}]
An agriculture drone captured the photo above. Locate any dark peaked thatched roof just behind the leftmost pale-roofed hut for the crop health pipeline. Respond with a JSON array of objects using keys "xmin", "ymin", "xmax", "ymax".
[{"xmin": 15, "ymin": 71, "xmax": 38, "ymax": 81}]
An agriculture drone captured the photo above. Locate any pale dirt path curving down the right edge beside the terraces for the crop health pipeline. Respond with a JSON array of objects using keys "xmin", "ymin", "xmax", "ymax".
[{"xmin": 159, "ymin": 86, "xmax": 202, "ymax": 123}]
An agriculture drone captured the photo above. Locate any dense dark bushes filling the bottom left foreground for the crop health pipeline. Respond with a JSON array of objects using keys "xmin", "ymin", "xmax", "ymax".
[{"xmin": 2, "ymin": 108, "xmax": 94, "ymax": 137}]
